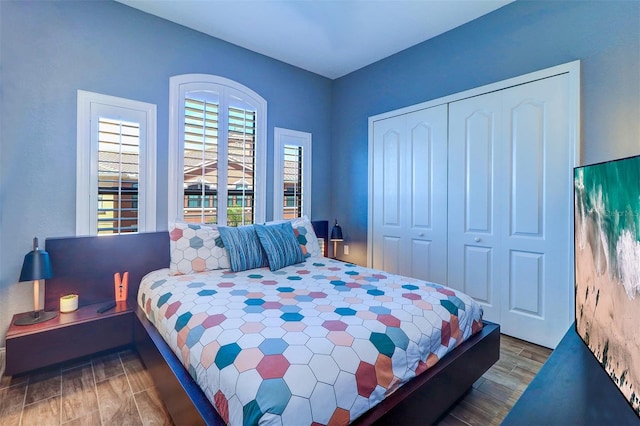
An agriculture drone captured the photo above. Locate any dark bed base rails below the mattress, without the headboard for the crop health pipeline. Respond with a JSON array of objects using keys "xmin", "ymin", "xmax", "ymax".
[{"xmin": 134, "ymin": 308, "xmax": 500, "ymax": 425}]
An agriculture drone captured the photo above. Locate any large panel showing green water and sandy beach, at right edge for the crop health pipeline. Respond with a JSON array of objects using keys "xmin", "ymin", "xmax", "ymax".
[{"xmin": 574, "ymin": 156, "xmax": 640, "ymax": 416}]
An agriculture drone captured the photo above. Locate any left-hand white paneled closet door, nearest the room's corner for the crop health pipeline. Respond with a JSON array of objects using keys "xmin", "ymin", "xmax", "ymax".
[{"xmin": 371, "ymin": 105, "xmax": 447, "ymax": 283}]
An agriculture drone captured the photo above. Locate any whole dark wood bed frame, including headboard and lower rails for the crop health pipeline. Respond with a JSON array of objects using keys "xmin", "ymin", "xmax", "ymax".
[{"xmin": 45, "ymin": 221, "xmax": 500, "ymax": 425}]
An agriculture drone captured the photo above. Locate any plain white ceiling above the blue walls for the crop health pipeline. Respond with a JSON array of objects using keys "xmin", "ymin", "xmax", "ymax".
[{"xmin": 117, "ymin": 0, "xmax": 513, "ymax": 79}]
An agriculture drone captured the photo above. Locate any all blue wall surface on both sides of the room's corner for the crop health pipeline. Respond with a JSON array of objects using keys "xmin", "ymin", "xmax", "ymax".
[{"xmin": 0, "ymin": 0, "xmax": 640, "ymax": 346}]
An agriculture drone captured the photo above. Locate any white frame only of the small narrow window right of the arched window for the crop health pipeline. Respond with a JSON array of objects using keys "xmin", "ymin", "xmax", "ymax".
[{"xmin": 273, "ymin": 127, "xmax": 312, "ymax": 220}]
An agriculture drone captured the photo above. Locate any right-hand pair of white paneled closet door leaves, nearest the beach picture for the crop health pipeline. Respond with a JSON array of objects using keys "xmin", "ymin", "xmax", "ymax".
[{"xmin": 448, "ymin": 74, "xmax": 574, "ymax": 347}]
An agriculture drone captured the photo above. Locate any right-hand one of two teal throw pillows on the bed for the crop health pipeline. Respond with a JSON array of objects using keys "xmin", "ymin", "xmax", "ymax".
[{"xmin": 253, "ymin": 221, "xmax": 304, "ymax": 271}]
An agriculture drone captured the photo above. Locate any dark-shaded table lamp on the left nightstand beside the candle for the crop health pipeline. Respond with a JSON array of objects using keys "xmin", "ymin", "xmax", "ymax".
[{"xmin": 13, "ymin": 238, "xmax": 58, "ymax": 325}]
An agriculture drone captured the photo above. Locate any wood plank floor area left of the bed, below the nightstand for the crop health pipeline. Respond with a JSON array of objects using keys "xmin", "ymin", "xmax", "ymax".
[{"xmin": 0, "ymin": 350, "xmax": 172, "ymax": 426}]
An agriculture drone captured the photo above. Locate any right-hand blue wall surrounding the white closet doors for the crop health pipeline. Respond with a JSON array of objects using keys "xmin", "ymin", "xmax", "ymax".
[{"xmin": 332, "ymin": 1, "xmax": 640, "ymax": 264}]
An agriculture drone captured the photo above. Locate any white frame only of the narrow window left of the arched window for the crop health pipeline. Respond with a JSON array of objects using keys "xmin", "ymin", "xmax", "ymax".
[{"xmin": 76, "ymin": 90, "xmax": 157, "ymax": 235}]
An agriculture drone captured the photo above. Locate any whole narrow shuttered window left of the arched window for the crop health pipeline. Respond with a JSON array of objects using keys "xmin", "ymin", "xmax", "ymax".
[{"xmin": 76, "ymin": 90, "xmax": 156, "ymax": 235}]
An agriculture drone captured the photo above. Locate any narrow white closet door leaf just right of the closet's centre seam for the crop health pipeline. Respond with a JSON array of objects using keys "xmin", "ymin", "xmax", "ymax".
[{"xmin": 448, "ymin": 92, "xmax": 508, "ymax": 323}]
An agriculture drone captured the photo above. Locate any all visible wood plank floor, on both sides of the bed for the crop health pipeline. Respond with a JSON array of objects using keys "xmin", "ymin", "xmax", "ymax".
[{"xmin": 0, "ymin": 335, "xmax": 551, "ymax": 426}]
